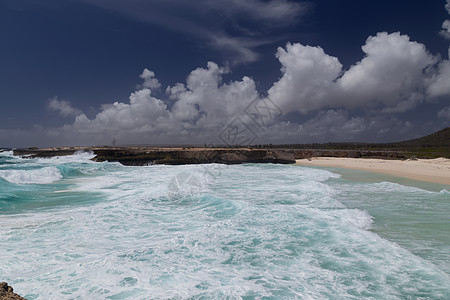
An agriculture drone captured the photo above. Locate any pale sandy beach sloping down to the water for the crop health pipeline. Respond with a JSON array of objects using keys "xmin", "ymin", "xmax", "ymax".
[{"xmin": 296, "ymin": 157, "xmax": 450, "ymax": 185}]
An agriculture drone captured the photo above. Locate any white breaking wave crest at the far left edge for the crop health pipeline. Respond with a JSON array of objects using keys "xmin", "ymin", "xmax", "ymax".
[{"xmin": 0, "ymin": 167, "xmax": 63, "ymax": 184}]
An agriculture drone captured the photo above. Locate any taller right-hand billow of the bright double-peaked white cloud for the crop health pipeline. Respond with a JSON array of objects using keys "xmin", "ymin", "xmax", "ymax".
[{"xmin": 337, "ymin": 32, "xmax": 436, "ymax": 112}]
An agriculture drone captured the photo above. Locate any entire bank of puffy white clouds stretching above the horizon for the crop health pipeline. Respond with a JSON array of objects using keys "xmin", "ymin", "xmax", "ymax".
[{"xmin": 41, "ymin": 32, "xmax": 450, "ymax": 144}]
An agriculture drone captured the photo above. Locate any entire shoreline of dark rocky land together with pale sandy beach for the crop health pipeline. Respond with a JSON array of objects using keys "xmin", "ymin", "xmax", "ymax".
[{"xmin": 0, "ymin": 147, "xmax": 450, "ymax": 186}]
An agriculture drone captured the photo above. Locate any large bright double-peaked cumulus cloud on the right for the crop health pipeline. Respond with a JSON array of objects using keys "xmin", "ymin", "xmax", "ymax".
[{"xmin": 268, "ymin": 32, "xmax": 442, "ymax": 113}]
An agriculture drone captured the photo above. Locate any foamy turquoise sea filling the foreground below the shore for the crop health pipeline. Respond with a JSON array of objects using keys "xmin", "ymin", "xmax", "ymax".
[{"xmin": 0, "ymin": 152, "xmax": 450, "ymax": 299}]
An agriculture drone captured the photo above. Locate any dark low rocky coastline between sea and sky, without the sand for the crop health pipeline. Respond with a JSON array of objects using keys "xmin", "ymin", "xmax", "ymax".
[{"xmin": 7, "ymin": 147, "xmax": 414, "ymax": 166}]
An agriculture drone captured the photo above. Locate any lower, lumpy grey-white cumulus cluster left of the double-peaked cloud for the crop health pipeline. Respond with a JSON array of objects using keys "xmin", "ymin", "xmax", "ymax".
[{"xmin": 55, "ymin": 62, "xmax": 258, "ymax": 144}]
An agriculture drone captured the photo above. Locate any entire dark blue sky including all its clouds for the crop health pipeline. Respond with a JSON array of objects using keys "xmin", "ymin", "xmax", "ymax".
[{"xmin": 0, "ymin": 0, "xmax": 450, "ymax": 147}]
